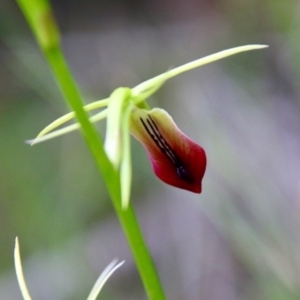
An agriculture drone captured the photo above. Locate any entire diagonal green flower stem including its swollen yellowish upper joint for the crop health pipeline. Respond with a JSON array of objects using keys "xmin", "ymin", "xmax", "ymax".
[{"xmin": 17, "ymin": 0, "xmax": 165, "ymax": 300}]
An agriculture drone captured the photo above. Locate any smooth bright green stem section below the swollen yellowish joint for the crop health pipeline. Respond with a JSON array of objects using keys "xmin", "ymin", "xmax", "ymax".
[{"xmin": 45, "ymin": 49, "xmax": 165, "ymax": 300}]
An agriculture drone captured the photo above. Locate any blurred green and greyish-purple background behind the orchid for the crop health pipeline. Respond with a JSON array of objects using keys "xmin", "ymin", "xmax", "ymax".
[{"xmin": 0, "ymin": 0, "xmax": 300, "ymax": 300}]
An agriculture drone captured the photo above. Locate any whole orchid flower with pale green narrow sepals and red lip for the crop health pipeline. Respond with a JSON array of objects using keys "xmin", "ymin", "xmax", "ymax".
[{"xmin": 28, "ymin": 45, "xmax": 267, "ymax": 209}]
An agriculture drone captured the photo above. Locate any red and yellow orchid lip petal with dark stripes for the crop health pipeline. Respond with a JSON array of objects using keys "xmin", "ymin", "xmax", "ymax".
[{"xmin": 130, "ymin": 108, "xmax": 206, "ymax": 193}]
